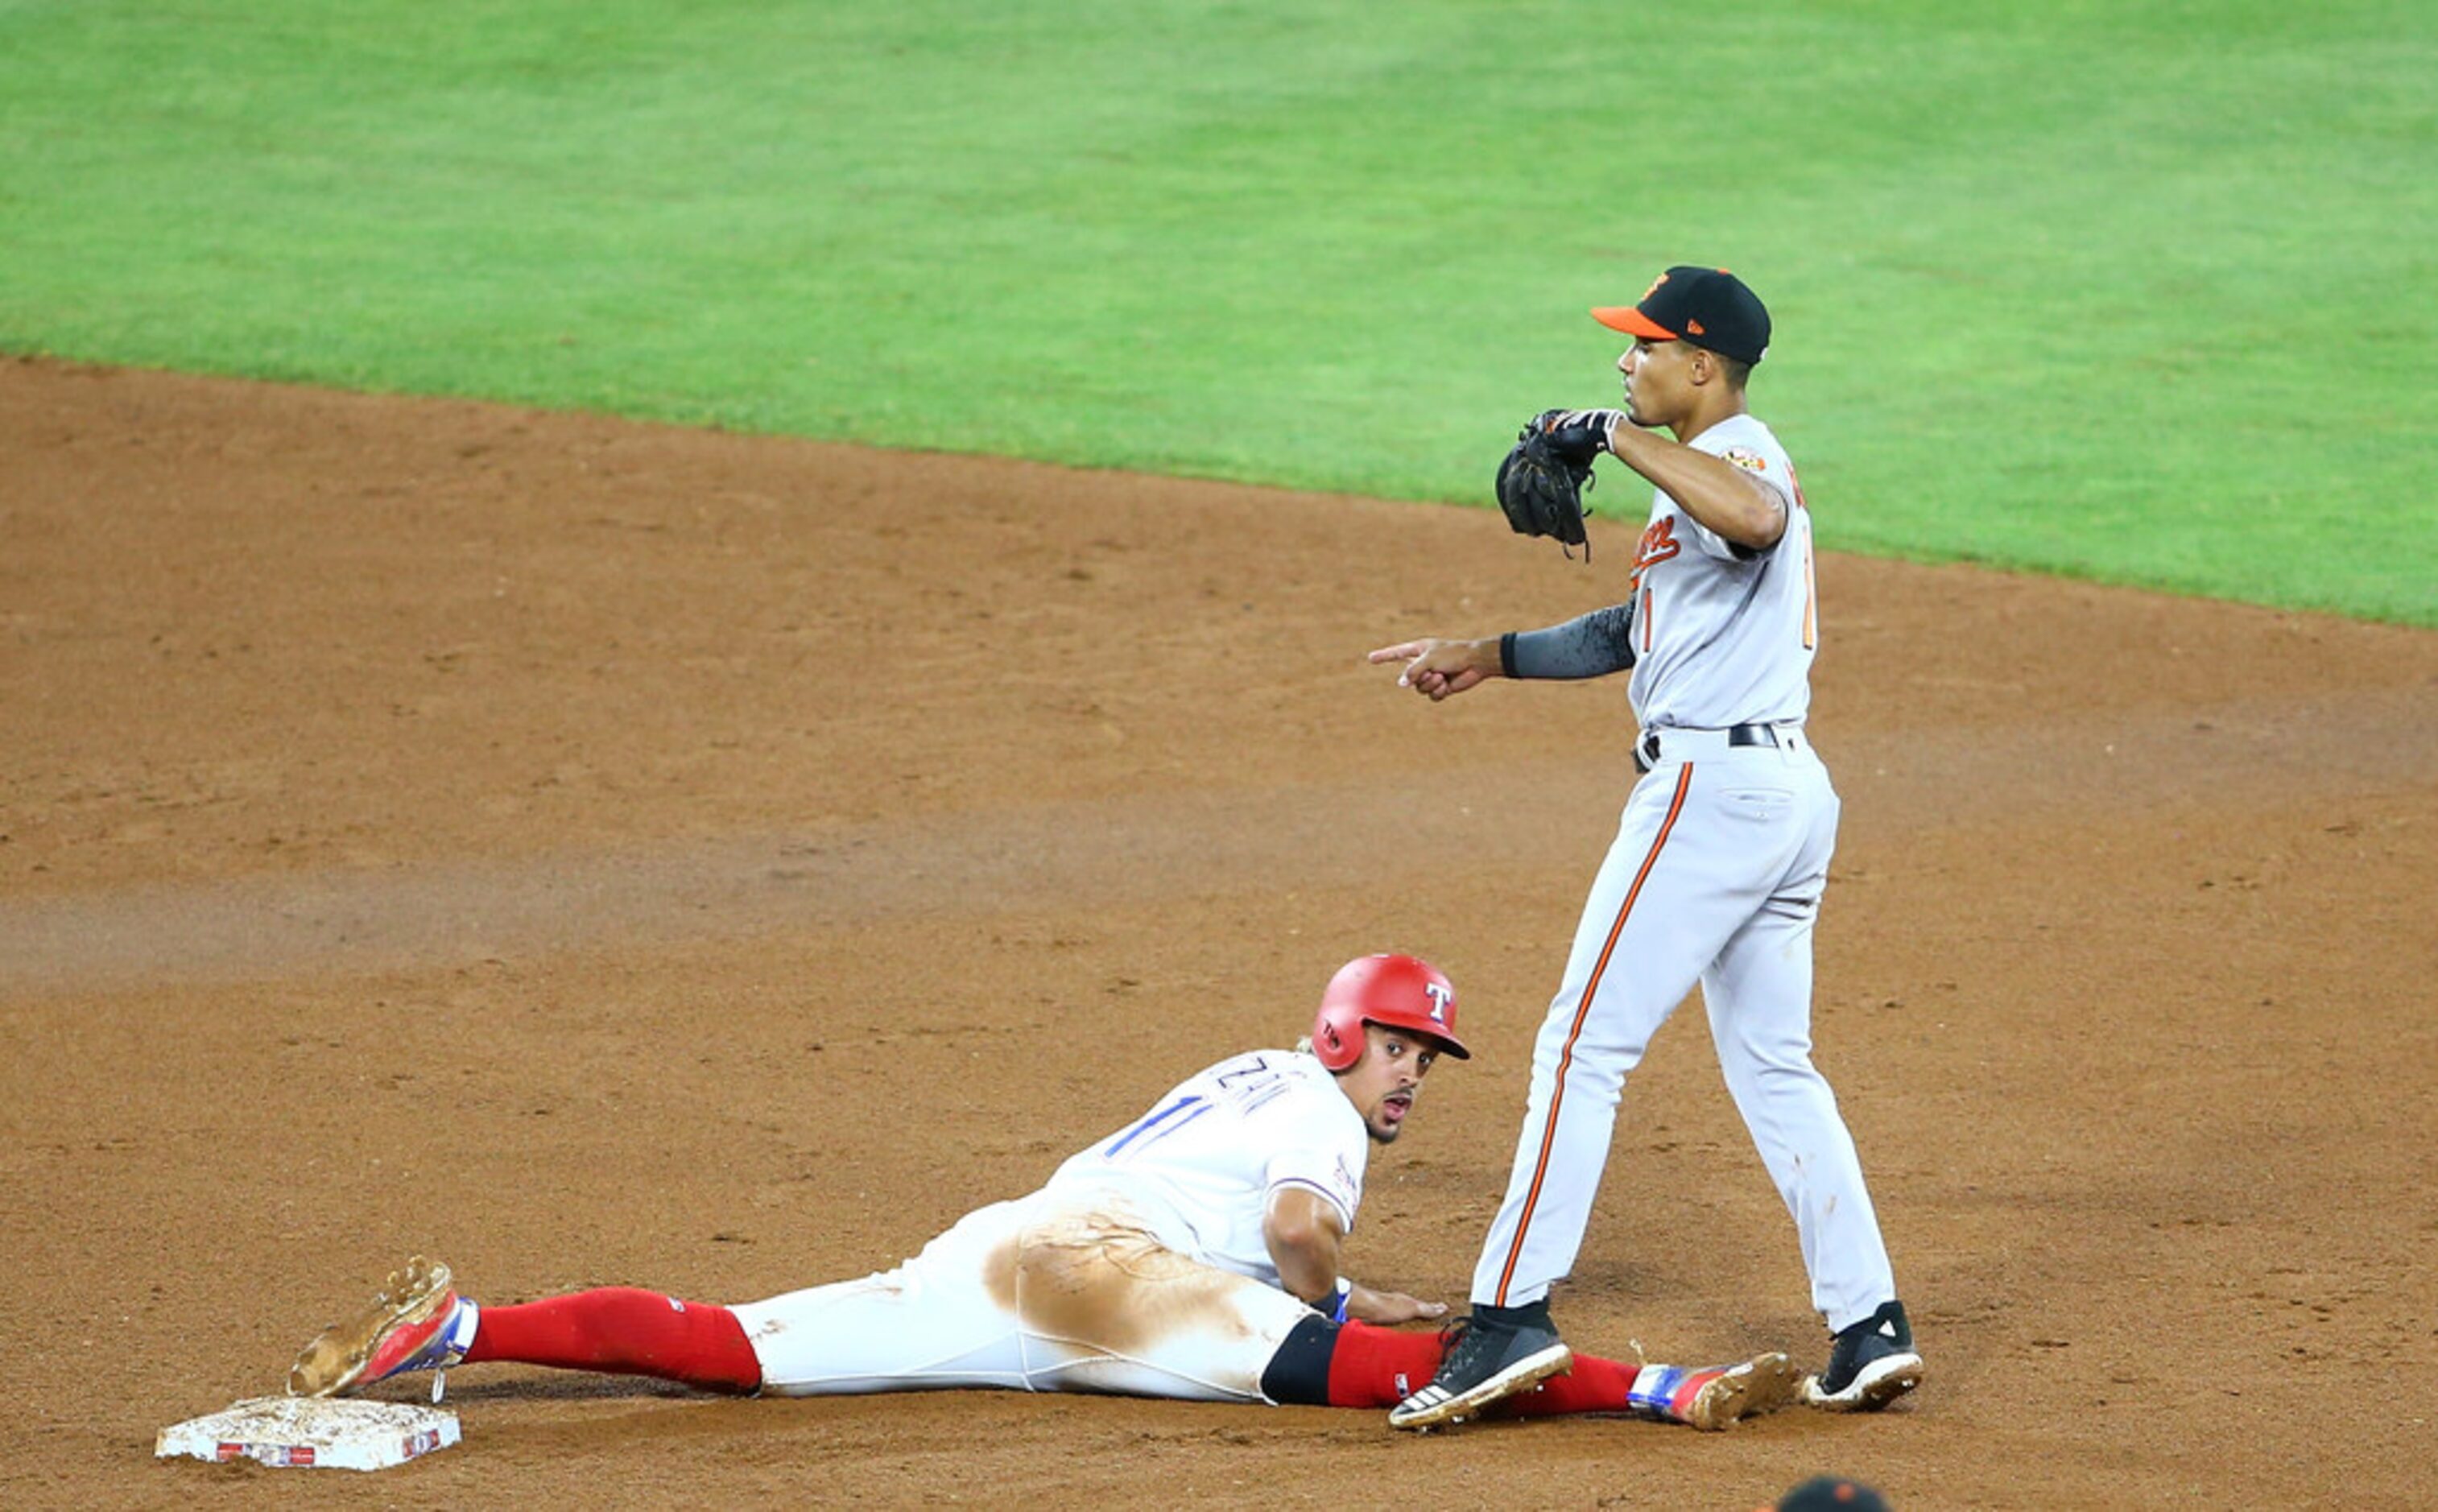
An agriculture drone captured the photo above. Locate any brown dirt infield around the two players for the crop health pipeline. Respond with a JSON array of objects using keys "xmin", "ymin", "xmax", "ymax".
[{"xmin": 0, "ymin": 361, "xmax": 2438, "ymax": 1510}]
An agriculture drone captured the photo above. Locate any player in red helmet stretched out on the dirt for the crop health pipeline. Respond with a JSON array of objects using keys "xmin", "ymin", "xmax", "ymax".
[{"xmin": 287, "ymin": 956, "xmax": 1797, "ymax": 1429}]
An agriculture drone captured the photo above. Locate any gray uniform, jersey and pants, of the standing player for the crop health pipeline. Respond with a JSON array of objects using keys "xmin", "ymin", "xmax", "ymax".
[{"xmin": 1473, "ymin": 415, "xmax": 1897, "ymax": 1329}]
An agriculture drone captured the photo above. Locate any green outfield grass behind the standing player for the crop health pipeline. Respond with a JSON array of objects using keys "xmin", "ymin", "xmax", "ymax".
[{"xmin": 0, "ymin": 0, "xmax": 2438, "ymax": 624}]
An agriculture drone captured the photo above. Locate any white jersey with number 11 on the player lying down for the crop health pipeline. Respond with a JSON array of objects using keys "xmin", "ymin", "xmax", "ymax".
[{"xmin": 1046, "ymin": 1051, "xmax": 1370, "ymax": 1285}]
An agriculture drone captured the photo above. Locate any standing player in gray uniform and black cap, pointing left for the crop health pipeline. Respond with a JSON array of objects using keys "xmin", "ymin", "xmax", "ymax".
[{"xmin": 1370, "ymin": 268, "xmax": 1921, "ymax": 1427}]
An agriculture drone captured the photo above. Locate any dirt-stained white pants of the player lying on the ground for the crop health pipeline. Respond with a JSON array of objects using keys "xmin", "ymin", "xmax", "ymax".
[{"xmin": 731, "ymin": 1192, "xmax": 1312, "ymax": 1403}]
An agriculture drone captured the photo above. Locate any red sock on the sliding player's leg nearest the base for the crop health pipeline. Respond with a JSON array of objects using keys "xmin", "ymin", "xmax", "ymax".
[{"xmin": 465, "ymin": 1285, "xmax": 761, "ymax": 1393}]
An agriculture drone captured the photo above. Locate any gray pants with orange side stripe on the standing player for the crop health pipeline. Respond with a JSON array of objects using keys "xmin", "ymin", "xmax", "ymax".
[{"xmin": 1473, "ymin": 729, "xmax": 1897, "ymax": 1329}]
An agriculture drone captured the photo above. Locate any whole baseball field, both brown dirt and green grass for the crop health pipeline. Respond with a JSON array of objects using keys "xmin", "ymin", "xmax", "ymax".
[{"xmin": 0, "ymin": 0, "xmax": 2438, "ymax": 1512}]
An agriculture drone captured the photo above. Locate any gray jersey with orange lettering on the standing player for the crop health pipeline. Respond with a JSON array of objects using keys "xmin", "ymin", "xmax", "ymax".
[{"xmin": 1631, "ymin": 415, "xmax": 1819, "ymax": 729}]
